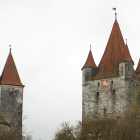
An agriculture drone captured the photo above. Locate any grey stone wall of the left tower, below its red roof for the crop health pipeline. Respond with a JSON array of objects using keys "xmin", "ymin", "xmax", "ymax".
[{"xmin": 0, "ymin": 85, "xmax": 23, "ymax": 136}]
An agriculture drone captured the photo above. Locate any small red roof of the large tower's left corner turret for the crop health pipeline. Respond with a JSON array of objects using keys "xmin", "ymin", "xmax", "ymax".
[{"xmin": 82, "ymin": 50, "xmax": 97, "ymax": 69}]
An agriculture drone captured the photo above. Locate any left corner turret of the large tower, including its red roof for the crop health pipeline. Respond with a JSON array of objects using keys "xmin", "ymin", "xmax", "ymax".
[{"xmin": 81, "ymin": 46, "xmax": 98, "ymax": 83}]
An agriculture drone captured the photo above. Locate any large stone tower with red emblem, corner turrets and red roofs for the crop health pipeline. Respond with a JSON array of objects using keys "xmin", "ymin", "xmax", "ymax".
[{"xmin": 82, "ymin": 17, "xmax": 140, "ymax": 119}]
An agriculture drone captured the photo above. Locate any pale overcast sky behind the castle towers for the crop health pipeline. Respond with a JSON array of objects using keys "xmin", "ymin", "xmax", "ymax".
[{"xmin": 0, "ymin": 0, "xmax": 140, "ymax": 140}]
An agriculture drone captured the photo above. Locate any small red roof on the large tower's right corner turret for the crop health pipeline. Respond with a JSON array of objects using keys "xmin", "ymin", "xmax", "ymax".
[{"xmin": 120, "ymin": 45, "xmax": 133, "ymax": 62}]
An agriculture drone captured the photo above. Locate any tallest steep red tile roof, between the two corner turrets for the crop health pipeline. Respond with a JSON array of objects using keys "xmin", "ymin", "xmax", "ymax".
[{"xmin": 93, "ymin": 22, "xmax": 125, "ymax": 79}]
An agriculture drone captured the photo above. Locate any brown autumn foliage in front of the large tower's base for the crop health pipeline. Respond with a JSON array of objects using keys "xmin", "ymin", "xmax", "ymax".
[{"xmin": 53, "ymin": 87, "xmax": 140, "ymax": 140}]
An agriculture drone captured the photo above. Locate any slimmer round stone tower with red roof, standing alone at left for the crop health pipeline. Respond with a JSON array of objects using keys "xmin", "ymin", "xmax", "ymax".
[{"xmin": 0, "ymin": 49, "xmax": 24, "ymax": 139}]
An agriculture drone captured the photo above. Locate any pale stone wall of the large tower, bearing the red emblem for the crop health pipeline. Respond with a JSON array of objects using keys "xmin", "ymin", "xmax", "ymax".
[{"xmin": 82, "ymin": 76, "xmax": 137, "ymax": 119}]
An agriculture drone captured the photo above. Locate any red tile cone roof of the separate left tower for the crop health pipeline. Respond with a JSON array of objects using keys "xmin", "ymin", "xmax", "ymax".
[{"xmin": 1, "ymin": 52, "xmax": 24, "ymax": 86}]
